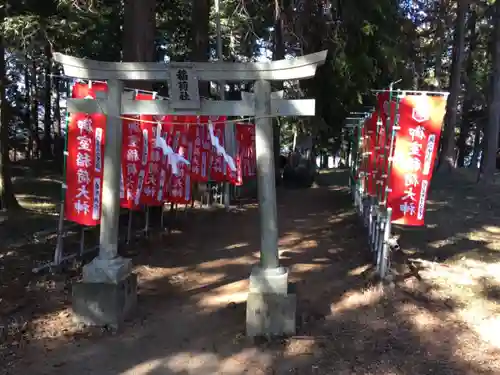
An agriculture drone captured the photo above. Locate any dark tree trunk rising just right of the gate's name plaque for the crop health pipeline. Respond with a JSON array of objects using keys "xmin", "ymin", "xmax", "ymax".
[{"xmin": 190, "ymin": 0, "xmax": 209, "ymax": 99}]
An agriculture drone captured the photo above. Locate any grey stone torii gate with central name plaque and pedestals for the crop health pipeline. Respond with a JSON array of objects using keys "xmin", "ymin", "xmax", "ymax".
[{"xmin": 54, "ymin": 51, "xmax": 327, "ymax": 336}]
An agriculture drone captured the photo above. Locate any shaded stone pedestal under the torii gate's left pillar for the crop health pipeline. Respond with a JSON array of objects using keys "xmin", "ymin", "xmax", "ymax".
[{"xmin": 72, "ymin": 258, "xmax": 137, "ymax": 329}]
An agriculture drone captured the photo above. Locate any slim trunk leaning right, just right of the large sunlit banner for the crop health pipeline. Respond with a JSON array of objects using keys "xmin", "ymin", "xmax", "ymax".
[{"xmin": 457, "ymin": 6, "xmax": 478, "ymax": 168}]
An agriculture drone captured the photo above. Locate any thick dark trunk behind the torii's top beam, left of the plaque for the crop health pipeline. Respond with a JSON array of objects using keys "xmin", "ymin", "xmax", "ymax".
[{"xmin": 122, "ymin": 0, "xmax": 156, "ymax": 90}]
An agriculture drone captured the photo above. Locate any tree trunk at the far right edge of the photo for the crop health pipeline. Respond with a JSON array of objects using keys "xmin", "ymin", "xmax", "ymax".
[{"xmin": 482, "ymin": 1, "xmax": 500, "ymax": 182}]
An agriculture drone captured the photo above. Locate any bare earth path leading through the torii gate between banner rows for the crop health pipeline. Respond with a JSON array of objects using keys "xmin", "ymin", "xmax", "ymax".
[{"xmin": 4, "ymin": 173, "xmax": 500, "ymax": 375}]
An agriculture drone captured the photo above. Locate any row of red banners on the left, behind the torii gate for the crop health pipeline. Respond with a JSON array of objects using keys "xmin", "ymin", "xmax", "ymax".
[{"xmin": 65, "ymin": 83, "xmax": 256, "ymax": 226}]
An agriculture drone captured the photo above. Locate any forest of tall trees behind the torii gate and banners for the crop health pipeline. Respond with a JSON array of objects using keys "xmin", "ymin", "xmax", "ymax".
[{"xmin": 0, "ymin": 0, "xmax": 500, "ymax": 209}]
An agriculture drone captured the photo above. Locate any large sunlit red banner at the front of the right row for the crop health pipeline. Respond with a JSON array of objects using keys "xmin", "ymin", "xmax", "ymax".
[{"xmin": 387, "ymin": 95, "xmax": 446, "ymax": 226}]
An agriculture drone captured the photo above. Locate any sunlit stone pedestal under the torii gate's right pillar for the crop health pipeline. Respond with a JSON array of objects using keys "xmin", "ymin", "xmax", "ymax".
[{"xmin": 246, "ymin": 267, "xmax": 297, "ymax": 337}]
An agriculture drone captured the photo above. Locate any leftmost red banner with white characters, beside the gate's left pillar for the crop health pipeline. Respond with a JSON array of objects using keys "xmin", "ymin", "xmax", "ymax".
[{"xmin": 64, "ymin": 83, "xmax": 107, "ymax": 226}]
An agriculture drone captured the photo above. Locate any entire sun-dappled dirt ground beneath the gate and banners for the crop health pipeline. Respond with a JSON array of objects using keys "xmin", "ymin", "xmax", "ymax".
[{"xmin": 0, "ymin": 168, "xmax": 500, "ymax": 375}]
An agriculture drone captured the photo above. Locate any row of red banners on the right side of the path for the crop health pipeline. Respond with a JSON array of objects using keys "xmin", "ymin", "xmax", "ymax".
[{"xmin": 358, "ymin": 92, "xmax": 446, "ymax": 226}]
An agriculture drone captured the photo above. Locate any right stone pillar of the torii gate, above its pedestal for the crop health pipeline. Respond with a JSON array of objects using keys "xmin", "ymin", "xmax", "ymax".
[{"xmin": 254, "ymin": 81, "xmax": 279, "ymax": 269}]
